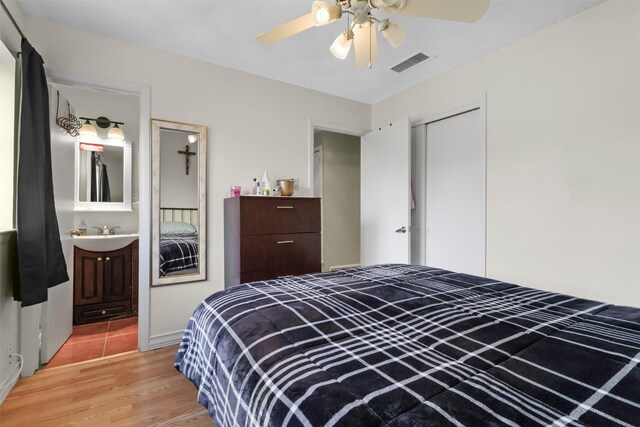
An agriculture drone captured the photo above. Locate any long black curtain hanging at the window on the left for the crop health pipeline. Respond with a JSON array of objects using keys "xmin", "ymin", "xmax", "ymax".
[{"xmin": 16, "ymin": 39, "xmax": 69, "ymax": 307}]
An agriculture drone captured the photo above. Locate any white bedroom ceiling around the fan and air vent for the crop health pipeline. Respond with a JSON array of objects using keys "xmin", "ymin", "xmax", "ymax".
[{"xmin": 18, "ymin": 0, "xmax": 602, "ymax": 104}]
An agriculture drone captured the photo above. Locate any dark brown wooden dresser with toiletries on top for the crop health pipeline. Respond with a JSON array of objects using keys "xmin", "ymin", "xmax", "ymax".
[{"xmin": 224, "ymin": 196, "xmax": 321, "ymax": 287}]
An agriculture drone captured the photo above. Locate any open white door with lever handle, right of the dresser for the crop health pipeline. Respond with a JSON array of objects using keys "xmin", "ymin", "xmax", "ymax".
[{"xmin": 360, "ymin": 118, "xmax": 411, "ymax": 265}]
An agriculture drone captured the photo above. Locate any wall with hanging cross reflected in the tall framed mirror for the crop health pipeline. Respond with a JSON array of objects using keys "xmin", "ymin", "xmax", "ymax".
[{"xmin": 160, "ymin": 130, "xmax": 199, "ymax": 209}]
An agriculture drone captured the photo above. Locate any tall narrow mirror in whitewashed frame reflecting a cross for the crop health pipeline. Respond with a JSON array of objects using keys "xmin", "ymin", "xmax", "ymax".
[{"xmin": 151, "ymin": 119, "xmax": 207, "ymax": 286}]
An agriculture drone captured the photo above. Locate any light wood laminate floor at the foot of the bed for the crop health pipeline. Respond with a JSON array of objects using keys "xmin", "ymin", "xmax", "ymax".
[{"xmin": 0, "ymin": 346, "xmax": 212, "ymax": 427}]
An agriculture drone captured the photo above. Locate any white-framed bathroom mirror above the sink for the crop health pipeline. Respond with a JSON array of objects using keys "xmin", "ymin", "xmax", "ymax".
[{"xmin": 74, "ymin": 137, "xmax": 131, "ymax": 211}]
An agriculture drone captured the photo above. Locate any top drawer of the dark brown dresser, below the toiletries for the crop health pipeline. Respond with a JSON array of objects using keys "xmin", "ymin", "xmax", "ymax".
[{"xmin": 240, "ymin": 197, "xmax": 320, "ymax": 236}]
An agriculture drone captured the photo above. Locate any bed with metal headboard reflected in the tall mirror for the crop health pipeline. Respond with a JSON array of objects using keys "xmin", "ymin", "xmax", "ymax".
[{"xmin": 159, "ymin": 208, "xmax": 199, "ymax": 277}]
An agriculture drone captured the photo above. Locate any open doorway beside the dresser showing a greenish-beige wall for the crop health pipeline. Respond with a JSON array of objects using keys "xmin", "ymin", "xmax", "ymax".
[{"xmin": 310, "ymin": 123, "xmax": 360, "ymax": 271}]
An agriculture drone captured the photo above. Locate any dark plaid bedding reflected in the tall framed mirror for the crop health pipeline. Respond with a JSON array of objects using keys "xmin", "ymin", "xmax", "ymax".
[{"xmin": 160, "ymin": 234, "xmax": 198, "ymax": 277}]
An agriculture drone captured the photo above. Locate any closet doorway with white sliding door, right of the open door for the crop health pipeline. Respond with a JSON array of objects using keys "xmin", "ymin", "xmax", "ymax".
[{"xmin": 411, "ymin": 98, "xmax": 486, "ymax": 276}]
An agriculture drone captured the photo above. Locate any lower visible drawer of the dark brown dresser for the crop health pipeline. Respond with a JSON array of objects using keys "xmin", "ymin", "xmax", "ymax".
[{"xmin": 240, "ymin": 233, "xmax": 320, "ymax": 273}]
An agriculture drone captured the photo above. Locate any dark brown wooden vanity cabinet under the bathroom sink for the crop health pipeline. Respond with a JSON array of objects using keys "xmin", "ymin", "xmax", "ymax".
[{"xmin": 73, "ymin": 240, "xmax": 138, "ymax": 324}]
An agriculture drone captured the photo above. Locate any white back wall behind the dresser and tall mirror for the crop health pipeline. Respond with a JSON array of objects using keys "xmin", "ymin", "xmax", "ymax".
[{"xmin": 25, "ymin": 17, "xmax": 371, "ymax": 336}]
